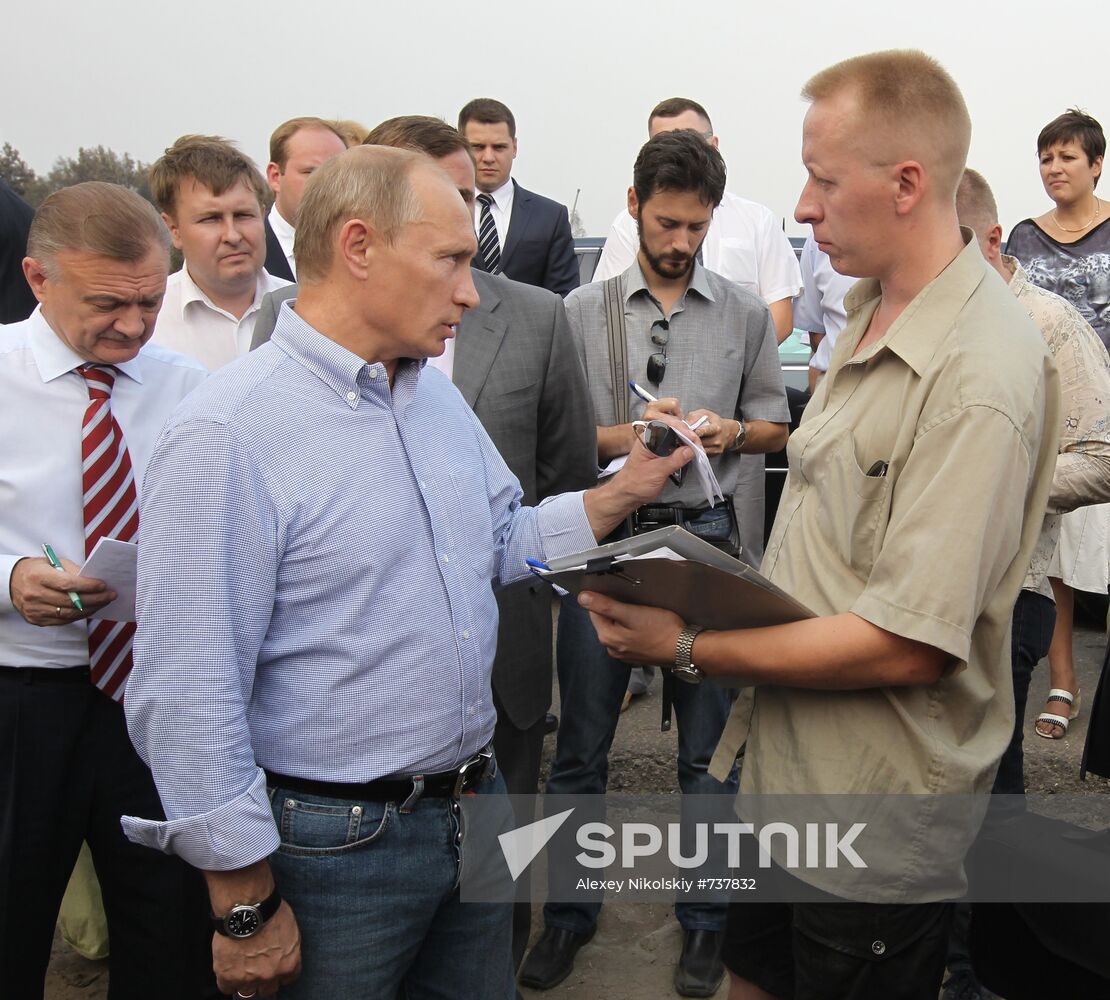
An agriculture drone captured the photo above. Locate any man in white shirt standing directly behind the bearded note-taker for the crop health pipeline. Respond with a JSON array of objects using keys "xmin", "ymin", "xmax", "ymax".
[{"xmin": 594, "ymin": 98, "xmax": 801, "ymax": 568}]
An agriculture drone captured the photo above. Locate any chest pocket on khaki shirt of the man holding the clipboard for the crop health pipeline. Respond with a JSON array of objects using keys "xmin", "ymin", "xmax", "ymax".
[{"xmin": 804, "ymin": 430, "xmax": 894, "ymax": 578}]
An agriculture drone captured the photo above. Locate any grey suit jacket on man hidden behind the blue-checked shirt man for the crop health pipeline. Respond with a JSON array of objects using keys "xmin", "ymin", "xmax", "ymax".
[{"xmin": 251, "ymin": 269, "xmax": 597, "ymax": 729}]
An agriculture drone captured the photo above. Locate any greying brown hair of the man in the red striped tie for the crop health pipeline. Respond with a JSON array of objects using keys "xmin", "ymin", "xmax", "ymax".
[{"xmin": 27, "ymin": 181, "xmax": 170, "ymax": 280}]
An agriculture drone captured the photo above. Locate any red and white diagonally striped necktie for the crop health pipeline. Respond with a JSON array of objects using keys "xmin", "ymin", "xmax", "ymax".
[{"xmin": 78, "ymin": 365, "xmax": 139, "ymax": 701}]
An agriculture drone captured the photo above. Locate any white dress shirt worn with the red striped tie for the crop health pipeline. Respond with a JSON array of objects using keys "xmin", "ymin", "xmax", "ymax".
[{"xmin": 0, "ymin": 309, "xmax": 205, "ymax": 667}]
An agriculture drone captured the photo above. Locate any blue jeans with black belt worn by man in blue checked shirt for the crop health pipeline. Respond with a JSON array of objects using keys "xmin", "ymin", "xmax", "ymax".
[{"xmin": 270, "ymin": 759, "xmax": 515, "ymax": 1000}]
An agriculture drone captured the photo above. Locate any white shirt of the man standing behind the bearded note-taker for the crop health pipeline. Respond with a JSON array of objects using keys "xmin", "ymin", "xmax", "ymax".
[{"xmin": 594, "ymin": 191, "xmax": 801, "ymax": 302}]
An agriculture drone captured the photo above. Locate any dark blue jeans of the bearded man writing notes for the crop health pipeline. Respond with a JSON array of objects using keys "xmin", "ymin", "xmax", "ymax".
[{"xmin": 544, "ymin": 597, "xmax": 737, "ymax": 933}]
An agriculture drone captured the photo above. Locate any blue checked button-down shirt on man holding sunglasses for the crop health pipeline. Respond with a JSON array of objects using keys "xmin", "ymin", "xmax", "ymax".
[{"xmin": 123, "ymin": 304, "xmax": 596, "ymax": 870}]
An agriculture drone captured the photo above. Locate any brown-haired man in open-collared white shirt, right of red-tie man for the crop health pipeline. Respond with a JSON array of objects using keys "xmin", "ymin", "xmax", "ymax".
[{"xmin": 150, "ymin": 135, "xmax": 289, "ymax": 372}]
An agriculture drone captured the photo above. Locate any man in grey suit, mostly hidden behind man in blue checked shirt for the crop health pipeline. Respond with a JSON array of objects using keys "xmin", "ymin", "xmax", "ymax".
[{"xmin": 251, "ymin": 115, "xmax": 597, "ymax": 966}]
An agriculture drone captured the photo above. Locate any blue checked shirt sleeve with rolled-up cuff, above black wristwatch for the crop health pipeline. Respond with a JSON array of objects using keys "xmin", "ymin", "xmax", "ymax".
[{"xmin": 123, "ymin": 420, "xmax": 282, "ymax": 870}]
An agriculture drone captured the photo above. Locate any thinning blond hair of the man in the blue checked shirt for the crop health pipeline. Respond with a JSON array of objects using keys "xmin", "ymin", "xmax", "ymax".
[{"xmin": 294, "ymin": 145, "xmax": 428, "ymax": 284}]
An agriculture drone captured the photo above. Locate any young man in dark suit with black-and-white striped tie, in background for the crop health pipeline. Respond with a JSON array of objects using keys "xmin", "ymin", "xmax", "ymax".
[{"xmin": 458, "ymin": 98, "xmax": 578, "ymax": 295}]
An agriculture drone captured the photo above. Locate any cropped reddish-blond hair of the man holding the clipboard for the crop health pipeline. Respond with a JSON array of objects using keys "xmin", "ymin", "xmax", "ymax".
[{"xmin": 801, "ymin": 49, "xmax": 971, "ymax": 198}]
